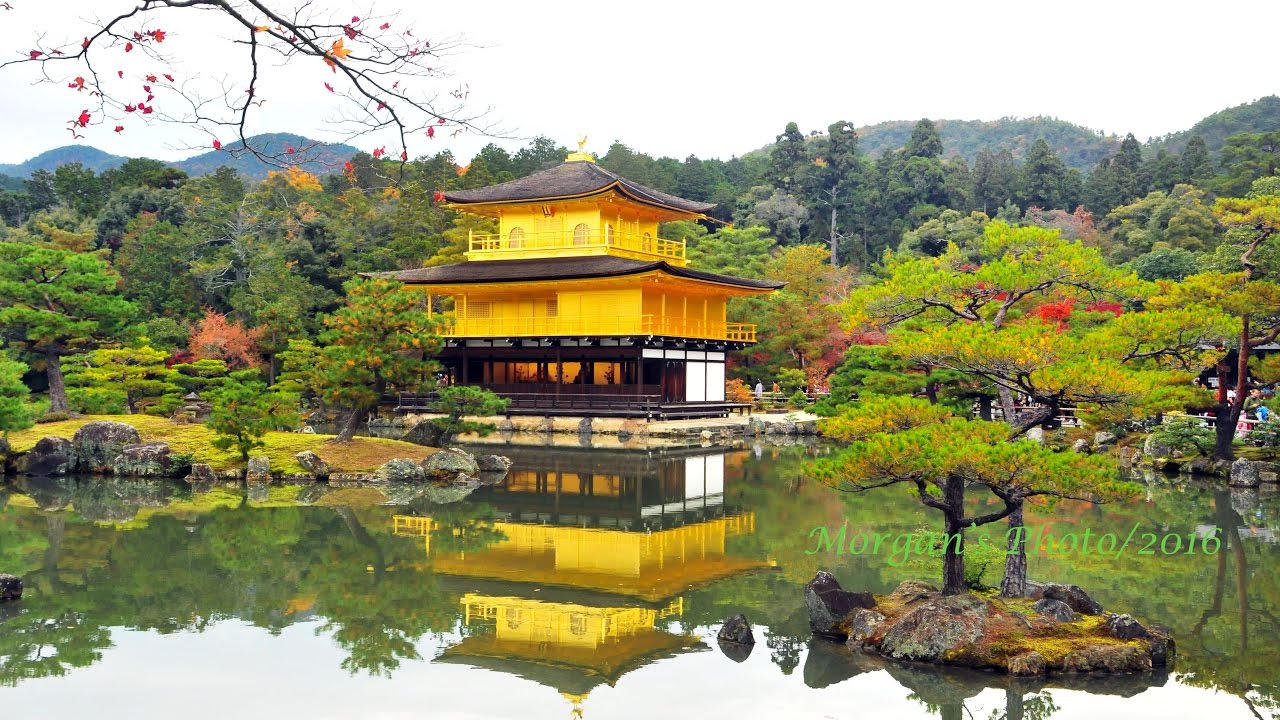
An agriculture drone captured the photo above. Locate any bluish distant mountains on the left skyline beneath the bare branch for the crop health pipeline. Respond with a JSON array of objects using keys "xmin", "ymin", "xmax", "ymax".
[{"xmin": 0, "ymin": 132, "xmax": 360, "ymax": 179}]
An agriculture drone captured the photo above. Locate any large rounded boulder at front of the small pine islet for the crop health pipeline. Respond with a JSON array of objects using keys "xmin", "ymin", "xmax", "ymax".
[{"xmin": 879, "ymin": 593, "xmax": 991, "ymax": 662}]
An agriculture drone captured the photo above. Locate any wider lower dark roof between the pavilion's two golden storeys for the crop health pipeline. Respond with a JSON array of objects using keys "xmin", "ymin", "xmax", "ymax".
[{"xmin": 369, "ymin": 255, "xmax": 787, "ymax": 290}]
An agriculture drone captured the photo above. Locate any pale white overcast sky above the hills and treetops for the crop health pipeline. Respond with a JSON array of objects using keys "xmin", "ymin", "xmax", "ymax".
[{"xmin": 0, "ymin": 0, "xmax": 1280, "ymax": 163}]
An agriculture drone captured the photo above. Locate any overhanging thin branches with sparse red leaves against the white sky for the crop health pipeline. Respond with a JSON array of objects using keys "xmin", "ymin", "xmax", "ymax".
[{"xmin": 0, "ymin": 0, "xmax": 483, "ymax": 167}]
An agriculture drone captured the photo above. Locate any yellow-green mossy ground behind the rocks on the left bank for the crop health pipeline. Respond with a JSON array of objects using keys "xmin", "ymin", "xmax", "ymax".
[{"xmin": 9, "ymin": 415, "xmax": 435, "ymax": 473}]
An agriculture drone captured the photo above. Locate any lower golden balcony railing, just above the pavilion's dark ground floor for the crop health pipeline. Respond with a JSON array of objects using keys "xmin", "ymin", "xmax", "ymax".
[{"xmin": 444, "ymin": 310, "xmax": 755, "ymax": 342}]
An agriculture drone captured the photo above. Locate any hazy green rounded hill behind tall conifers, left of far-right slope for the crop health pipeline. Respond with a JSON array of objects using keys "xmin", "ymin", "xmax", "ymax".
[{"xmin": 858, "ymin": 118, "xmax": 1120, "ymax": 172}]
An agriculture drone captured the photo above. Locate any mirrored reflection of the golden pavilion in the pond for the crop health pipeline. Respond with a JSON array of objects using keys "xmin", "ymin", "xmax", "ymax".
[{"xmin": 393, "ymin": 447, "xmax": 771, "ymax": 716}]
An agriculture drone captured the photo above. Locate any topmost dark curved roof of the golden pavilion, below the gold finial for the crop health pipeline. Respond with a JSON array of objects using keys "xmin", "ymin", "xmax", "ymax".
[{"xmin": 444, "ymin": 160, "xmax": 716, "ymax": 213}]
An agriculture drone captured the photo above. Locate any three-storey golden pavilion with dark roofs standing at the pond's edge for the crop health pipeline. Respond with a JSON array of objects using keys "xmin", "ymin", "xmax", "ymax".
[{"xmin": 383, "ymin": 147, "xmax": 783, "ymax": 418}]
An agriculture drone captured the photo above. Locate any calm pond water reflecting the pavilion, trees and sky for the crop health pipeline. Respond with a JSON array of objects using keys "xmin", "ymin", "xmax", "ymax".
[{"xmin": 0, "ymin": 447, "xmax": 1280, "ymax": 720}]
